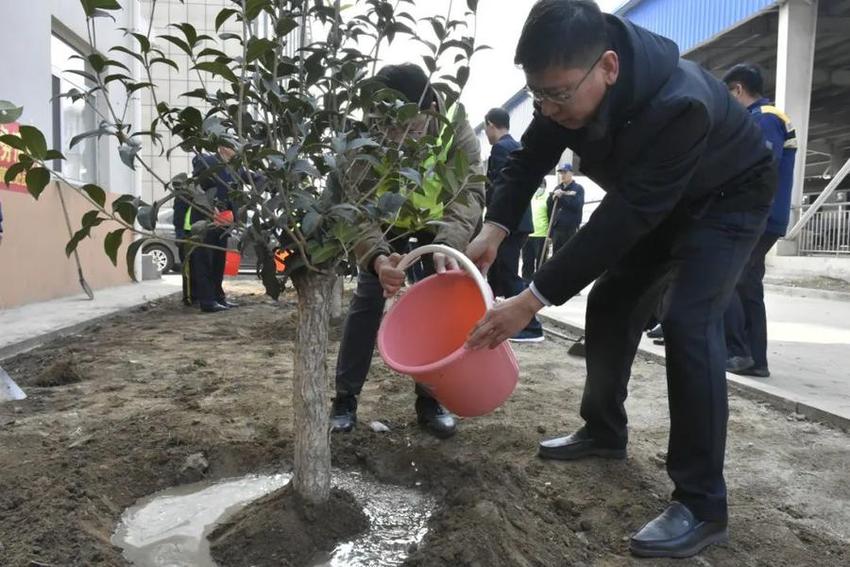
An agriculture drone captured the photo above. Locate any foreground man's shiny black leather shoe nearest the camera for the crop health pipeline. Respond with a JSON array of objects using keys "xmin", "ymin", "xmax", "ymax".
[{"xmin": 629, "ymin": 502, "xmax": 729, "ymax": 557}]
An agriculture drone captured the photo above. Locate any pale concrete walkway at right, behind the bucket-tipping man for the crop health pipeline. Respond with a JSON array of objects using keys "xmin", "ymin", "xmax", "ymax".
[{"xmin": 541, "ymin": 286, "xmax": 850, "ymax": 428}]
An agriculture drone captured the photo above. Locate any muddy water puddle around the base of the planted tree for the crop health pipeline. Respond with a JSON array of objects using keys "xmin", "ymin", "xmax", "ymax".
[{"xmin": 112, "ymin": 473, "xmax": 436, "ymax": 567}]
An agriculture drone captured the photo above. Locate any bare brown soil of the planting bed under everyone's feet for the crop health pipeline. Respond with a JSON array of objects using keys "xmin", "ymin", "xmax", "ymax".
[{"xmin": 0, "ymin": 281, "xmax": 850, "ymax": 567}]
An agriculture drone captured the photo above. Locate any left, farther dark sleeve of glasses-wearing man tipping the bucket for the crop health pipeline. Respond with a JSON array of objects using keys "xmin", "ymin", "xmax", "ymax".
[{"xmin": 486, "ymin": 116, "xmax": 567, "ymax": 231}]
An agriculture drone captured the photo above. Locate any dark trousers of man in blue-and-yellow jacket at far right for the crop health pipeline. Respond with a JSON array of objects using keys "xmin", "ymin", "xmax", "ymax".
[{"xmin": 723, "ymin": 232, "xmax": 779, "ymax": 368}]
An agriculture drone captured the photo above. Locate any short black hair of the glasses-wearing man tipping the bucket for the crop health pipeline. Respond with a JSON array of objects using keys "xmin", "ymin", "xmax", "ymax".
[{"xmin": 514, "ymin": 0, "xmax": 608, "ymax": 73}]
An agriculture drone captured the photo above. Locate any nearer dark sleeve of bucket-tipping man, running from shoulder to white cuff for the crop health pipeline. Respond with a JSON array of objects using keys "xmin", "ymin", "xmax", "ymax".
[{"xmin": 534, "ymin": 102, "xmax": 710, "ymax": 305}]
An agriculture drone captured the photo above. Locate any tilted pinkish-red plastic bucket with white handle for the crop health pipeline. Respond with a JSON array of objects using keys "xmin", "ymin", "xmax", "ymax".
[{"xmin": 378, "ymin": 244, "xmax": 519, "ymax": 417}]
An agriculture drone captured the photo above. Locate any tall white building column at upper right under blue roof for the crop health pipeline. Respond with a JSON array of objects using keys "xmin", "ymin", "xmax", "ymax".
[{"xmin": 776, "ymin": 0, "xmax": 818, "ymax": 255}]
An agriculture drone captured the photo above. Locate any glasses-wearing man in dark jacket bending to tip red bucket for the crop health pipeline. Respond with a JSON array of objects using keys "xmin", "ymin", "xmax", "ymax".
[{"xmin": 467, "ymin": 0, "xmax": 776, "ymax": 557}]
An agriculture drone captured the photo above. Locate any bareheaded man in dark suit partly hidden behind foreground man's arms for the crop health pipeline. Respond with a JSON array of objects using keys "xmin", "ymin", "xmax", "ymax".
[{"xmin": 484, "ymin": 108, "xmax": 543, "ymax": 343}]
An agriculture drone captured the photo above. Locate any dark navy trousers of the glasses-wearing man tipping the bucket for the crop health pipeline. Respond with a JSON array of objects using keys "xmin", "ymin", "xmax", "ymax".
[{"xmin": 581, "ymin": 204, "xmax": 773, "ymax": 520}]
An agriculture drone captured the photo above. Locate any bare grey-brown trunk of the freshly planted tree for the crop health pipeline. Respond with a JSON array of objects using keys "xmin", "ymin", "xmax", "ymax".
[{"xmin": 292, "ymin": 270, "xmax": 337, "ymax": 505}]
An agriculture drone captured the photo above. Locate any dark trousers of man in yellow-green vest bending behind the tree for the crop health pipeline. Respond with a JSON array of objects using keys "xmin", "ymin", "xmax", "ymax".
[{"xmin": 336, "ymin": 237, "xmax": 434, "ymax": 398}]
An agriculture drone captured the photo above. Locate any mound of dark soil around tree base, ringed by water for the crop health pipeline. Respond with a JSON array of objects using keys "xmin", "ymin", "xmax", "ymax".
[{"xmin": 209, "ymin": 485, "xmax": 369, "ymax": 567}]
